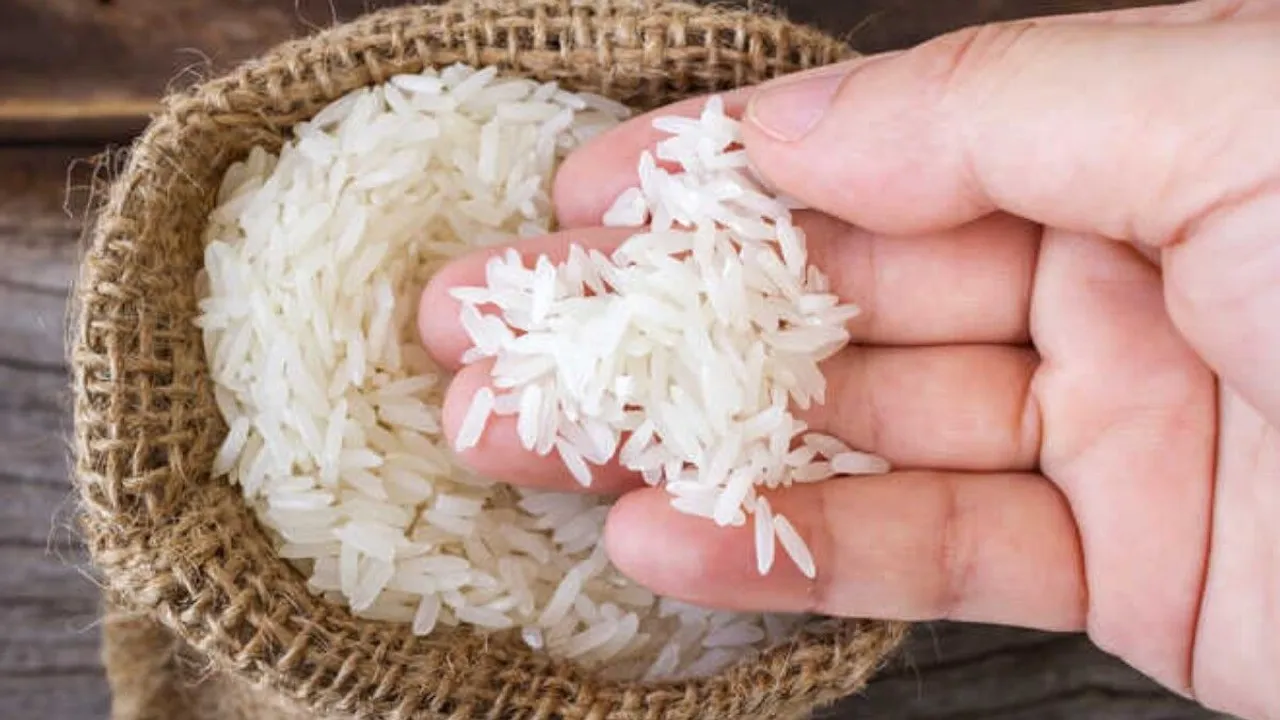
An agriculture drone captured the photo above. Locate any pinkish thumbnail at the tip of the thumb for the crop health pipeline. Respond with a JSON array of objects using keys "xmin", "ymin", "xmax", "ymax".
[{"xmin": 746, "ymin": 65, "xmax": 850, "ymax": 142}]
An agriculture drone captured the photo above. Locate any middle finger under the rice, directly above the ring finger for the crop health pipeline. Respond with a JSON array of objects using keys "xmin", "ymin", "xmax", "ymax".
[{"xmin": 419, "ymin": 213, "xmax": 1038, "ymax": 369}]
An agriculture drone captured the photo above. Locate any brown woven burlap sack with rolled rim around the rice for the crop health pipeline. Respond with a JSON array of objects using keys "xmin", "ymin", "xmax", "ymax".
[{"xmin": 72, "ymin": 0, "xmax": 904, "ymax": 720}]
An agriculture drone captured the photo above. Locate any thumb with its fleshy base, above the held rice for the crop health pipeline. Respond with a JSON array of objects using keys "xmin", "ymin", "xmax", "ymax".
[{"xmin": 744, "ymin": 14, "xmax": 1280, "ymax": 421}]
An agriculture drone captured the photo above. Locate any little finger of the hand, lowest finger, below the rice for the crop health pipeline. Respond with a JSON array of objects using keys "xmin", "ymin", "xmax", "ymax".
[{"xmin": 605, "ymin": 473, "xmax": 1087, "ymax": 630}]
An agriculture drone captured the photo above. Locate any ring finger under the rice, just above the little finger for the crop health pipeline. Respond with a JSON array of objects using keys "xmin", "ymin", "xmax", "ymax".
[{"xmin": 444, "ymin": 346, "xmax": 1041, "ymax": 495}]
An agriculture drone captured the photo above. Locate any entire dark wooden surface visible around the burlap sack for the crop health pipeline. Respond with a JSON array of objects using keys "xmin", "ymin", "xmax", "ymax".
[{"xmin": 0, "ymin": 0, "xmax": 1233, "ymax": 720}]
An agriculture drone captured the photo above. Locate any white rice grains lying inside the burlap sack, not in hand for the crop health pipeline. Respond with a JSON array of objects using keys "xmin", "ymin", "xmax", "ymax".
[{"xmin": 197, "ymin": 65, "xmax": 799, "ymax": 679}]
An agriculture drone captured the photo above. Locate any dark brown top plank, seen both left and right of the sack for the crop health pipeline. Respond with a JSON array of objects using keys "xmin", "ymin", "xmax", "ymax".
[{"xmin": 0, "ymin": 0, "xmax": 1158, "ymax": 141}]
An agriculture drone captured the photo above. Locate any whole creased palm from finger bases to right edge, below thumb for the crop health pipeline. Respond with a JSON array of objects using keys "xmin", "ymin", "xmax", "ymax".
[{"xmin": 1030, "ymin": 221, "xmax": 1280, "ymax": 712}]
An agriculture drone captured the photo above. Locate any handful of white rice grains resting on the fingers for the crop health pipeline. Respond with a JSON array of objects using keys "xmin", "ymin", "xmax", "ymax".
[{"xmin": 452, "ymin": 97, "xmax": 888, "ymax": 578}]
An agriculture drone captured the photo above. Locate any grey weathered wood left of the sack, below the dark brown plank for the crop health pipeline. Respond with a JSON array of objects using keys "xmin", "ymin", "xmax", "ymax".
[{"xmin": 0, "ymin": 140, "xmax": 109, "ymax": 720}]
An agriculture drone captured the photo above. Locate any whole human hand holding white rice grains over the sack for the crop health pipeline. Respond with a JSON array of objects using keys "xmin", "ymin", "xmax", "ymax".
[{"xmin": 424, "ymin": 0, "xmax": 1280, "ymax": 717}]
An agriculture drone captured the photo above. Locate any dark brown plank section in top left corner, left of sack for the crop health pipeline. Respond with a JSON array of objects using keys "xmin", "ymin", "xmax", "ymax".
[{"xmin": 0, "ymin": 0, "xmax": 370, "ymax": 140}]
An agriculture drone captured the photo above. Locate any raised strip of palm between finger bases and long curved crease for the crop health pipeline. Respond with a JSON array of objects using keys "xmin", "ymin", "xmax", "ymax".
[{"xmin": 1030, "ymin": 224, "xmax": 1217, "ymax": 689}]
